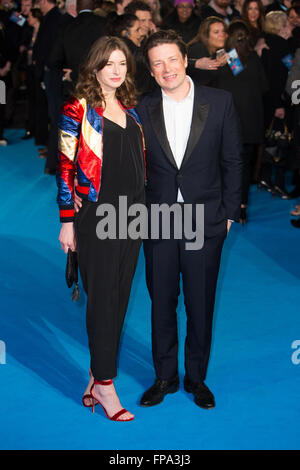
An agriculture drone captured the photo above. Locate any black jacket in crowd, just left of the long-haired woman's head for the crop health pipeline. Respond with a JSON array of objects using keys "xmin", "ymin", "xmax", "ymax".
[{"xmin": 50, "ymin": 12, "xmax": 105, "ymax": 83}]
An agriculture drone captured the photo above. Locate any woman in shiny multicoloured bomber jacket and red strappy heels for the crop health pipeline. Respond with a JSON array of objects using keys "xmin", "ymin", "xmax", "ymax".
[{"xmin": 57, "ymin": 37, "xmax": 144, "ymax": 421}]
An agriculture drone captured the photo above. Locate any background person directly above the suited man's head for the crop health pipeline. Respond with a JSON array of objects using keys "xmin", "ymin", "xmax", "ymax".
[{"xmin": 161, "ymin": 0, "xmax": 201, "ymax": 44}]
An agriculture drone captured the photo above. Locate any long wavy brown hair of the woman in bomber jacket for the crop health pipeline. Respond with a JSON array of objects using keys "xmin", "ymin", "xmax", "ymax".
[{"xmin": 74, "ymin": 36, "xmax": 137, "ymax": 108}]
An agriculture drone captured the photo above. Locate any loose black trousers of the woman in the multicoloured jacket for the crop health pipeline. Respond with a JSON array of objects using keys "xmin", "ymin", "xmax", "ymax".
[{"xmin": 75, "ymin": 201, "xmax": 141, "ymax": 380}]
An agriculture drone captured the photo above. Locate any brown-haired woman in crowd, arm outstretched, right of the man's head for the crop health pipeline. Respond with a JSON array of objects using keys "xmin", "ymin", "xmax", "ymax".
[{"xmin": 188, "ymin": 16, "xmax": 227, "ymax": 85}]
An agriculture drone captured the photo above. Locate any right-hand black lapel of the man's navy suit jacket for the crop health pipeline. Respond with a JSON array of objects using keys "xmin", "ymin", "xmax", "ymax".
[{"xmin": 181, "ymin": 98, "xmax": 209, "ymax": 167}]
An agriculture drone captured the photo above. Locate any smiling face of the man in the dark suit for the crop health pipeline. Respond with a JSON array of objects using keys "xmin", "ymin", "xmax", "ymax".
[{"xmin": 148, "ymin": 44, "xmax": 187, "ymax": 94}]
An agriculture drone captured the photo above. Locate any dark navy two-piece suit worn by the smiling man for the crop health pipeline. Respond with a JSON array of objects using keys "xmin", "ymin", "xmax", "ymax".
[{"xmin": 137, "ymin": 85, "xmax": 242, "ymax": 382}]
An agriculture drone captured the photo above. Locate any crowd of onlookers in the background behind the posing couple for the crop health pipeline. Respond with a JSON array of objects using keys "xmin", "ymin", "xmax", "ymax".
[{"xmin": 0, "ymin": 0, "xmax": 300, "ymax": 226}]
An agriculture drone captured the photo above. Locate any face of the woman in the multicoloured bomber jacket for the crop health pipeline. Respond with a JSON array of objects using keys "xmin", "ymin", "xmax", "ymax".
[{"xmin": 96, "ymin": 49, "xmax": 127, "ymax": 93}]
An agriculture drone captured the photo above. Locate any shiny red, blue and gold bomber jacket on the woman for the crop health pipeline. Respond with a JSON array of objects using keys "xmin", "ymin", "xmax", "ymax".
[{"xmin": 56, "ymin": 97, "xmax": 145, "ymax": 222}]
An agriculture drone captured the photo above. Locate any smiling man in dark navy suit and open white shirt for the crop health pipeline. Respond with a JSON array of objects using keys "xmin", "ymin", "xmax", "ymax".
[{"xmin": 137, "ymin": 31, "xmax": 242, "ymax": 409}]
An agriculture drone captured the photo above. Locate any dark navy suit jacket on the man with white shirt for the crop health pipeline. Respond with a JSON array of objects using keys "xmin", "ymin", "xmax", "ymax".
[{"xmin": 136, "ymin": 85, "xmax": 243, "ymax": 237}]
